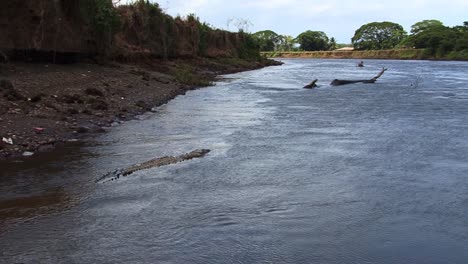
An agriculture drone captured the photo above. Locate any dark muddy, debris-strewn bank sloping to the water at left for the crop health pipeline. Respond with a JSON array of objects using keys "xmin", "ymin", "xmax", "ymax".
[{"xmin": 0, "ymin": 58, "xmax": 278, "ymax": 159}]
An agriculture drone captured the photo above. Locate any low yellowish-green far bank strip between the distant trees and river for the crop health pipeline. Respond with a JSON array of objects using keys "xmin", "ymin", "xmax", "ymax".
[{"xmin": 262, "ymin": 49, "xmax": 468, "ymax": 60}]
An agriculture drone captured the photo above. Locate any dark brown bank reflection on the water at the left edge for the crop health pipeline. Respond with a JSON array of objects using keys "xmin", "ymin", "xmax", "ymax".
[{"xmin": 0, "ymin": 144, "xmax": 92, "ymax": 231}]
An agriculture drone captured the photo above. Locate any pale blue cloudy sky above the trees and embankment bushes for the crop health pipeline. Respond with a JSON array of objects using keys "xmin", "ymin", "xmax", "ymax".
[{"xmin": 121, "ymin": 0, "xmax": 468, "ymax": 43}]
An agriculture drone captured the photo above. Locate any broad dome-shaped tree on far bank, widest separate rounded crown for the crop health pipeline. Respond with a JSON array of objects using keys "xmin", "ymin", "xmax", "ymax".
[{"xmin": 351, "ymin": 21, "xmax": 406, "ymax": 50}]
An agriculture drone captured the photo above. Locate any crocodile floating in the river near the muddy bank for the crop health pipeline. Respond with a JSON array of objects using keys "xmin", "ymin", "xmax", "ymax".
[{"xmin": 96, "ymin": 149, "xmax": 210, "ymax": 183}]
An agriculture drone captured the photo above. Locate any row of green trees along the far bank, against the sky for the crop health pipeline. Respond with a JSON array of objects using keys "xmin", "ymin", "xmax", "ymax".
[{"xmin": 253, "ymin": 20, "xmax": 468, "ymax": 58}]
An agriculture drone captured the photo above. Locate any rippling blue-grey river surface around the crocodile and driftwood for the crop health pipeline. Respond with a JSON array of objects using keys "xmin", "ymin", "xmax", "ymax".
[{"xmin": 0, "ymin": 59, "xmax": 468, "ymax": 264}]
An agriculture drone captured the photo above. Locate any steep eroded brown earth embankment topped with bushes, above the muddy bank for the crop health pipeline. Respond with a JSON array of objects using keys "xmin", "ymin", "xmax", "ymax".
[{"xmin": 0, "ymin": 0, "xmax": 258, "ymax": 63}]
